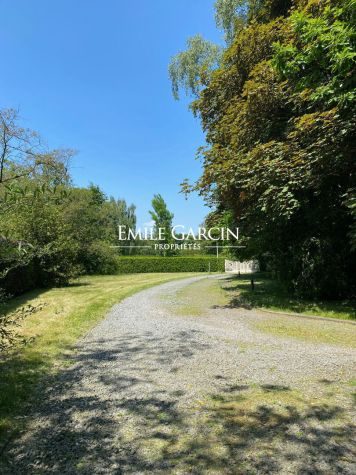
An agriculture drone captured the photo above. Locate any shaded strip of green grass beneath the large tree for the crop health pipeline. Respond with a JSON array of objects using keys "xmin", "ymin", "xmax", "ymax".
[{"xmin": 225, "ymin": 274, "xmax": 356, "ymax": 320}]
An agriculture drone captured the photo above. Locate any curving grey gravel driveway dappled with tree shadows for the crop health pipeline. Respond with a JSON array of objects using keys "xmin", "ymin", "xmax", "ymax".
[{"xmin": 3, "ymin": 277, "xmax": 356, "ymax": 475}]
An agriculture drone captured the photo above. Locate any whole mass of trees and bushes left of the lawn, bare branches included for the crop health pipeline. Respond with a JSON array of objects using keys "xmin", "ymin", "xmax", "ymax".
[{"xmin": 0, "ymin": 110, "xmax": 136, "ymax": 308}]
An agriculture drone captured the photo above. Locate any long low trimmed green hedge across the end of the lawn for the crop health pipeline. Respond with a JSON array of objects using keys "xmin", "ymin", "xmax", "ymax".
[{"xmin": 118, "ymin": 256, "xmax": 225, "ymax": 274}]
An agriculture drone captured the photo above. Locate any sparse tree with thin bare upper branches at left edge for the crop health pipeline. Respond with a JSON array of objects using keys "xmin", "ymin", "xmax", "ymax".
[{"xmin": 0, "ymin": 109, "xmax": 73, "ymax": 288}]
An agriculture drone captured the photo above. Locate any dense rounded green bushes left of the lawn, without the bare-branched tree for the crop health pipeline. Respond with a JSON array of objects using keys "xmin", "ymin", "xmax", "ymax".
[{"xmin": 0, "ymin": 186, "xmax": 135, "ymax": 294}]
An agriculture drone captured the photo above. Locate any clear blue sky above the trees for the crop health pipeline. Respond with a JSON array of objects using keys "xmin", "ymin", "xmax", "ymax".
[{"xmin": 0, "ymin": 0, "xmax": 221, "ymax": 231}]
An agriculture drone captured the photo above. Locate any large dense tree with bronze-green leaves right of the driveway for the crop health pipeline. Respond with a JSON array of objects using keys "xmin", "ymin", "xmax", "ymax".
[{"xmin": 171, "ymin": 0, "xmax": 356, "ymax": 297}]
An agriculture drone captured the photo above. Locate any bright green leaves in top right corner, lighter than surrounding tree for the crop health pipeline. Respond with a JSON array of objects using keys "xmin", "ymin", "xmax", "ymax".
[{"xmin": 272, "ymin": 0, "xmax": 356, "ymax": 108}]
